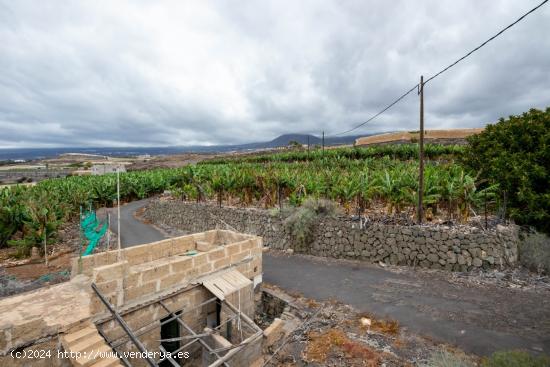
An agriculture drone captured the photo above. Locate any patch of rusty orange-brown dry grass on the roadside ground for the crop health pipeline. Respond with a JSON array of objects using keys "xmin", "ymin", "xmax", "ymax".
[{"xmin": 304, "ymin": 329, "xmax": 381, "ymax": 367}]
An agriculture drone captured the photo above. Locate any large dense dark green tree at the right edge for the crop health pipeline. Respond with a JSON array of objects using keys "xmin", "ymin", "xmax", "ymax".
[{"xmin": 463, "ymin": 108, "xmax": 550, "ymax": 233}]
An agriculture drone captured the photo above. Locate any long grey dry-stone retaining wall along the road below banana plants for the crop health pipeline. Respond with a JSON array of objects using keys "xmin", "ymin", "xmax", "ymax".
[{"xmin": 145, "ymin": 201, "xmax": 519, "ymax": 271}]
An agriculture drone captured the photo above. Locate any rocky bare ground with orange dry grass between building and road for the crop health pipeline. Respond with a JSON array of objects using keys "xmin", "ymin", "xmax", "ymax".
[{"xmin": 264, "ymin": 283, "xmax": 478, "ymax": 367}]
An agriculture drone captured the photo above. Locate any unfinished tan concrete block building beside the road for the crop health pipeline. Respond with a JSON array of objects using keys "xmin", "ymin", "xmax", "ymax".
[{"xmin": 0, "ymin": 230, "xmax": 262, "ymax": 367}]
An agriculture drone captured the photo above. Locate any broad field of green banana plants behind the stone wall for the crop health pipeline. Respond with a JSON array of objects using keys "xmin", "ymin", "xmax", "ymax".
[{"xmin": 0, "ymin": 144, "xmax": 497, "ymax": 256}]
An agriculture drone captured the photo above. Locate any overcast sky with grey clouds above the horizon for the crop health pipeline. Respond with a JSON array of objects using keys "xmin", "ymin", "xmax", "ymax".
[{"xmin": 0, "ymin": 0, "xmax": 550, "ymax": 148}]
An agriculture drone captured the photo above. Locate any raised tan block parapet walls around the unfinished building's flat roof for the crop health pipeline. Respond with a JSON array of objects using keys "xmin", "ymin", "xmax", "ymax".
[{"xmin": 73, "ymin": 230, "xmax": 262, "ymax": 314}]
